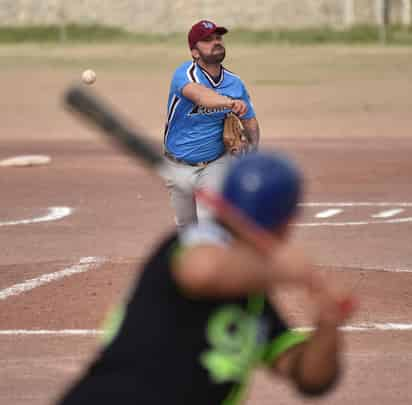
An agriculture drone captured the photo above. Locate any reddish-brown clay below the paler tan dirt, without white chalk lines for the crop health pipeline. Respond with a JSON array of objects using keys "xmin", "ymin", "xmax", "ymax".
[{"xmin": 0, "ymin": 139, "xmax": 412, "ymax": 405}]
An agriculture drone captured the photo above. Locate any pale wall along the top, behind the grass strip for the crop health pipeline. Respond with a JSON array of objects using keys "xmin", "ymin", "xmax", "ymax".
[{"xmin": 0, "ymin": 0, "xmax": 409, "ymax": 32}]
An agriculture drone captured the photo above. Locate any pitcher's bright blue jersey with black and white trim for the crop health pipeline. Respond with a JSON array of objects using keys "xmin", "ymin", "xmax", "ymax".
[{"xmin": 164, "ymin": 61, "xmax": 255, "ymax": 163}]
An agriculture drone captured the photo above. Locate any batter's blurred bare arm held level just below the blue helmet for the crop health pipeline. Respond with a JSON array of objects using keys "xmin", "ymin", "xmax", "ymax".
[{"xmin": 174, "ymin": 238, "xmax": 313, "ymax": 297}]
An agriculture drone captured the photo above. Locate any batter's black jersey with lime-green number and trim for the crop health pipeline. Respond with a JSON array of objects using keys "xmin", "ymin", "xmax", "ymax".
[{"xmin": 61, "ymin": 226, "xmax": 304, "ymax": 405}]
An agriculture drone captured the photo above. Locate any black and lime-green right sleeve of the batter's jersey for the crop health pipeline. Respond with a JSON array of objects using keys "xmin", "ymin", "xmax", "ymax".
[{"xmin": 261, "ymin": 296, "xmax": 309, "ymax": 367}]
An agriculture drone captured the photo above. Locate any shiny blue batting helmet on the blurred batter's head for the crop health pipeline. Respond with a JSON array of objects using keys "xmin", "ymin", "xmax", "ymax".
[{"xmin": 222, "ymin": 152, "xmax": 302, "ymax": 230}]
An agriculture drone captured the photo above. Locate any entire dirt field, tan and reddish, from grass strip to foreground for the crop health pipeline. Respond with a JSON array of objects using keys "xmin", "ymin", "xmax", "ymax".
[{"xmin": 0, "ymin": 42, "xmax": 412, "ymax": 405}]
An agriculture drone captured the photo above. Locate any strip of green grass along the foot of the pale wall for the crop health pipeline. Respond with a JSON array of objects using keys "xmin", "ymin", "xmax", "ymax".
[{"xmin": 0, "ymin": 24, "xmax": 412, "ymax": 45}]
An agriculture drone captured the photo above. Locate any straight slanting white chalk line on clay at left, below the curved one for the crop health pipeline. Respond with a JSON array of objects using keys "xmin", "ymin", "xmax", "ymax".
[{"xmin": 0, "ymin": 257, "xmax": 104, "ymax": 300}]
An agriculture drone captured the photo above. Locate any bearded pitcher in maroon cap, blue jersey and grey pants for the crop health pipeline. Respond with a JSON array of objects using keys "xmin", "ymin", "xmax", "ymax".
[{"xmin": 164, "ymin": 20, "xmax": 259, "ymax": 229}]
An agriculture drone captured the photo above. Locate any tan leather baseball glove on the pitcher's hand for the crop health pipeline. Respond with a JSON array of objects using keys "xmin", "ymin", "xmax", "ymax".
[{"xmin": 223, "ymin": 112, "xmax": 249, "ymax": 155}]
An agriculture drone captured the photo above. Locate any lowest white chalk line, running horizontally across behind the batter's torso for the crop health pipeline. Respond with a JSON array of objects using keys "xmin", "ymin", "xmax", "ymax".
[{"xmin": 0, "ymin": 323, "xmax": 412, "ymax": 336}]
